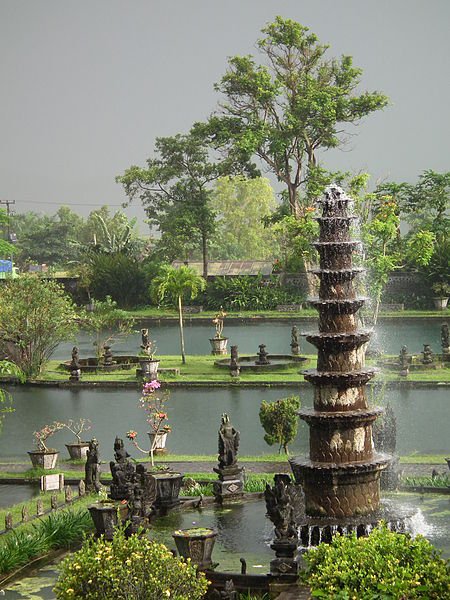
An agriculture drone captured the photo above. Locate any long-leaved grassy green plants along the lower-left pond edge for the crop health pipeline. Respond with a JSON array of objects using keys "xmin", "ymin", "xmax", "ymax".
[{"xmin": 0, "ymin": 509, "xmax": 92, "ymax": 574}]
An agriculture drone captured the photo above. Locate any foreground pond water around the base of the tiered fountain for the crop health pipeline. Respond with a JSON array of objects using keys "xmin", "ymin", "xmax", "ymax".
[{"xmin": 4, "ymin": 494, "xmax": 450, "ymax": 600}]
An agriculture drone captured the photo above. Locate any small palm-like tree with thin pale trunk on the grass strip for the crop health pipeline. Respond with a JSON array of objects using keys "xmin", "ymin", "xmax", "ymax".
[{"xmin": 150, "ymin": 265, "xmax": 206, "ymax": 364}]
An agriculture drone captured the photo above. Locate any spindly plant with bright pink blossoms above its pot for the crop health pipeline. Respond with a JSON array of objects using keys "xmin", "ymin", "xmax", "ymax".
[{"xmin": 127, "ymin": 379, "xmax": 172, "ymax": 467}]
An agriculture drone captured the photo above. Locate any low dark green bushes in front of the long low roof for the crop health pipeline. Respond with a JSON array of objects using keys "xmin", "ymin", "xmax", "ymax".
[{"xmin": 204, "ymin": 275, "xmax": 299, "ymax": 311}]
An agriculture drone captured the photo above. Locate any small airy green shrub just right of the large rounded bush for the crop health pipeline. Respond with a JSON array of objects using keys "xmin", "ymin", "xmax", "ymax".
[{"xmin": 79, "ymin": 296, "xmax": 133, "ymax": 358}]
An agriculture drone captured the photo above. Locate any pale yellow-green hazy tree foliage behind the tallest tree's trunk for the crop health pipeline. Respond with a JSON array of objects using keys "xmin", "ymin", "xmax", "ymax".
[{"xmin": 211, "ymin": 175, "xmax": 278, "ymax": 260}]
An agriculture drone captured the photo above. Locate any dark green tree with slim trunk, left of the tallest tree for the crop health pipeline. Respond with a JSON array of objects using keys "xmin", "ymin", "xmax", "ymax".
[{"xmin": 117, "ymin": 133, "xmax": 226, "ymax": 277}]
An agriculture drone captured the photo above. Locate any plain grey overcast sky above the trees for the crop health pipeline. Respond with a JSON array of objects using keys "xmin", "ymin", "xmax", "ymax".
[{"xmin": 0, "ymin": 0, "xmax": 450, "ymax": 233}]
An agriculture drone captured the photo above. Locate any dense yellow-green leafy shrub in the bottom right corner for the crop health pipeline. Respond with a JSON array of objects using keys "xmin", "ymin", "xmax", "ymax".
[{"xmin": 302, "ymin": 525, "xmax": 450, "ymax": 600}]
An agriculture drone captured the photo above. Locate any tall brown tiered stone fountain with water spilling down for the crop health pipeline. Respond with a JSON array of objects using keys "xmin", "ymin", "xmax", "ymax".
[{"xmin": 289, "ymin": 186, "xmax": 402, "ymax": 545}]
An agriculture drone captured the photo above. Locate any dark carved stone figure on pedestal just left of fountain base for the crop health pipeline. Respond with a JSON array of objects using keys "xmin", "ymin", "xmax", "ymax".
[{"xmin": 264, "ymin": 473, "xmax": 300, "ymax": 540}]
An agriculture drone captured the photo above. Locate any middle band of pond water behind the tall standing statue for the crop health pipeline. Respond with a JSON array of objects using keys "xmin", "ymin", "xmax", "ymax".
[{"xmin": 0, "ymin": 386, "xmax": 450, "ymax": 462}]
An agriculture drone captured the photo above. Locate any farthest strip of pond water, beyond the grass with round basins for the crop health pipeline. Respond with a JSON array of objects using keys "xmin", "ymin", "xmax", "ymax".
[{"xmin": 53, "ymin": 318, "xmax": 442, "ymax": 360}]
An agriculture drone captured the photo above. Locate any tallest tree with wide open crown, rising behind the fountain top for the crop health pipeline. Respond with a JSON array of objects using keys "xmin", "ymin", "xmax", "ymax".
[{"xmin": 195, "ymin": 17, "xmax": 388, "ymax": 216}]
